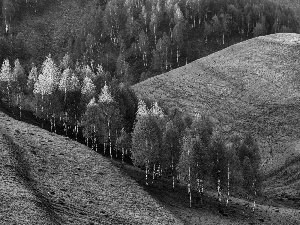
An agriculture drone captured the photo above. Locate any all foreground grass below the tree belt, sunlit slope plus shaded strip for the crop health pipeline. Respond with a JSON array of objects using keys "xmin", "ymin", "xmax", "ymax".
[{"xmin": 0, "ymin": 110, "xmax": 300, "ymax": 225}]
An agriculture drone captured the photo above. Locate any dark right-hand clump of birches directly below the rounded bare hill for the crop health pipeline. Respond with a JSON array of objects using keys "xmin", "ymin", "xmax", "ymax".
[{"xmin": 131, "ymin": 100, "xmax": 261, "ymax": 209}]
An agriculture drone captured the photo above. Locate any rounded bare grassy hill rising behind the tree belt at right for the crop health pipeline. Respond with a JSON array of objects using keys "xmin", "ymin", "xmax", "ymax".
[{"xmin": 134, "ymin": 34, "xmax": 300, "ymax": 186}]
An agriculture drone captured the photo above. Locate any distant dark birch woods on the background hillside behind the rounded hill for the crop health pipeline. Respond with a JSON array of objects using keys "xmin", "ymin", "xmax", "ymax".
[{"xmin": 0, "ymin": 0, "xmax": 298, "ymax": 84}]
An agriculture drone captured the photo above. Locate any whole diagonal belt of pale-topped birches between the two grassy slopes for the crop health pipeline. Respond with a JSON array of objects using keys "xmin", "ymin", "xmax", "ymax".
[{"xmin": 0, "ymin": 55, "xmax": 261, "ymax": 208}]
